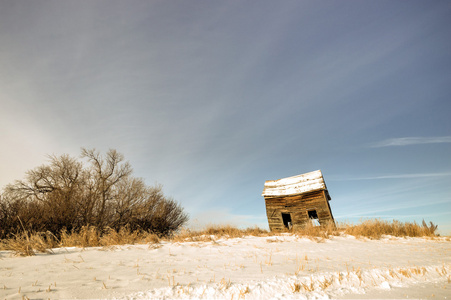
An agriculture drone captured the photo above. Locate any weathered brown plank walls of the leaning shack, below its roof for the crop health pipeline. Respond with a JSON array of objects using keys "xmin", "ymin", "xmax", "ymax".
[{"xmin": 265, "ymin": 190, "xmax": 334, "ymax": 231}]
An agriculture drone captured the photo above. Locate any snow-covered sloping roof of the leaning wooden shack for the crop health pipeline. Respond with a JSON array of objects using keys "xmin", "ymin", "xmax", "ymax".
[{"xmin": 262, "ymin": 170, "xmax": 327, "ymax": 197}]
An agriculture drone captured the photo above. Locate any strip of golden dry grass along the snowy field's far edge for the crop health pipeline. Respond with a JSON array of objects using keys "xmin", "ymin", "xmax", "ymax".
[{"xmin": 0, "ymin": 219, "xmax": 438, "ymax": 256}]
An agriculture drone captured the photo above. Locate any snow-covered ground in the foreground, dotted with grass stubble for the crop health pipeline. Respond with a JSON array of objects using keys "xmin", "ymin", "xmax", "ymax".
[{"xmin": 0, "ymin": 235, "xmax": 451, "ymax": 299}]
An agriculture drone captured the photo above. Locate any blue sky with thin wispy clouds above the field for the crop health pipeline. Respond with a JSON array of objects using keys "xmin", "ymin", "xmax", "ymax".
[{"xmin": 0, "ymin": 0, "xmax": 451, "ymax": 234}]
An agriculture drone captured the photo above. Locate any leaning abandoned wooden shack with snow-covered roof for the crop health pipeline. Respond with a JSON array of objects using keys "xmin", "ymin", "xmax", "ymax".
[{"xmin": 262, "ymin": 170, "xmax": 335, "ymax": 231}]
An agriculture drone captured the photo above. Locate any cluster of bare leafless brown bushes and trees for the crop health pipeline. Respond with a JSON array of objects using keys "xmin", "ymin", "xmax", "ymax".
[{"xmin": 0, "ymin": 149, "xmax": 188, "ymax": 239}]
